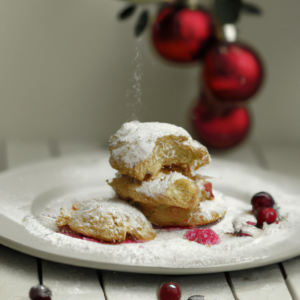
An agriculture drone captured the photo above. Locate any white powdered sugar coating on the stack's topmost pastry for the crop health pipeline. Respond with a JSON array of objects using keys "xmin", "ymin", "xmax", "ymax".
[{"xmin": 109, "ymin": 121, "xmax": 204, "ymax": 168}]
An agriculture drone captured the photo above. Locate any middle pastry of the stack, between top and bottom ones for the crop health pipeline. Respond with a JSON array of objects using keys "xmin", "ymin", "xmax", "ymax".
[{"xmin": 108, "ymin": 172, "xmax": 206, "ymax": 210}]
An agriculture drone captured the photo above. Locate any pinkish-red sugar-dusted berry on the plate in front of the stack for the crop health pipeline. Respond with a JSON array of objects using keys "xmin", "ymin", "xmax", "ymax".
[{"xmin": 184, "ymin": 228, "xmax": 221, "ymax": 245}]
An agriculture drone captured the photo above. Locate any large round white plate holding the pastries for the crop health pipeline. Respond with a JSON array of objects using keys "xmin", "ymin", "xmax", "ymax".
[{"xmin": 0, "ymin": 154, "xmax": 300, "ymax": 274}]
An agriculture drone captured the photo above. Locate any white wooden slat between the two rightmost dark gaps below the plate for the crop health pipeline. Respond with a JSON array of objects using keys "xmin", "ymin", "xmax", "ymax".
[{"xmin": 230, "ymin": 264, "xmax": 292, "ymax": 300}]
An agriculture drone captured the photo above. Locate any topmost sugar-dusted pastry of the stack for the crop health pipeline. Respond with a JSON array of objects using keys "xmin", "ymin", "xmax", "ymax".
[{"xmin": 109, "ymin": 121, "xmax": 210, "ymax": 180}]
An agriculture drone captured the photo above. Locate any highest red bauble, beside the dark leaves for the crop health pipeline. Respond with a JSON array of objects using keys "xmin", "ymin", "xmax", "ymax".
[{"xmin": 152, "ymin": 5, "xmax": 213, "ymax": 63}]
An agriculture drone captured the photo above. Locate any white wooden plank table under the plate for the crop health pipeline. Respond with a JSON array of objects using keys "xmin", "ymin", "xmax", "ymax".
[{"xmin": 0, "ymin": 140, "xmax": 300, "ymax": 300}]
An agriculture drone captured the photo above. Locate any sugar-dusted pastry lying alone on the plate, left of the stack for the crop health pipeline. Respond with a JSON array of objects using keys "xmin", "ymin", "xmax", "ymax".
[{"xmin": 57, "ymin": 199, "xmax": 156, "ymax": 242}]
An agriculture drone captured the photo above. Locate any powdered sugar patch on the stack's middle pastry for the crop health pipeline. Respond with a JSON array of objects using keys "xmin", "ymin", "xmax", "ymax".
[{"xmin": 136, "ymin": 172, "xmax": 192, "ymax": 197}]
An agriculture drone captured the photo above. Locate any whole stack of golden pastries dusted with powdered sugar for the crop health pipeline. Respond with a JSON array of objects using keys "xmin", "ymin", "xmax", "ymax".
[{"xmin": 109, "ymin": 121, "xmax": 226, "ymax": 226}]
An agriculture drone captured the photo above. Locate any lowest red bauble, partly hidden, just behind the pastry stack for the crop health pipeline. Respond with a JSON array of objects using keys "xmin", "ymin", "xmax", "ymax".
[{"xmin": 192, "ymin": 95, "xmax": 250, "ymax": 149}]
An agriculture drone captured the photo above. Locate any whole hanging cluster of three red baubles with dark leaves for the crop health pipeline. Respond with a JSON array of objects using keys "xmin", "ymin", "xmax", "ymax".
[{"xmin": 115, "ymin": 0, "xmax": 263, "ymax": 149}]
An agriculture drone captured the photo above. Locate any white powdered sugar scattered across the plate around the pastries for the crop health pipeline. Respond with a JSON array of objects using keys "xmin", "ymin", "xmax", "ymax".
[{"xmin": 23, "ymin": 191, "xmax": 300, "ymax": 268}]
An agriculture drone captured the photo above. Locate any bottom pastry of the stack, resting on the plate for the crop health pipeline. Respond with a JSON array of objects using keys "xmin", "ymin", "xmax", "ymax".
[{"xmin": 133, "ymin": 193, "xmax": 226, "ymax": 227}]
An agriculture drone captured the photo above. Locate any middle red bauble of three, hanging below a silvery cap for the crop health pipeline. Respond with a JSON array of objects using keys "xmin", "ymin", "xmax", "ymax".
[{"xmin": 203, "ymin": 42, "xmax": 263, "ymax": 103}]
